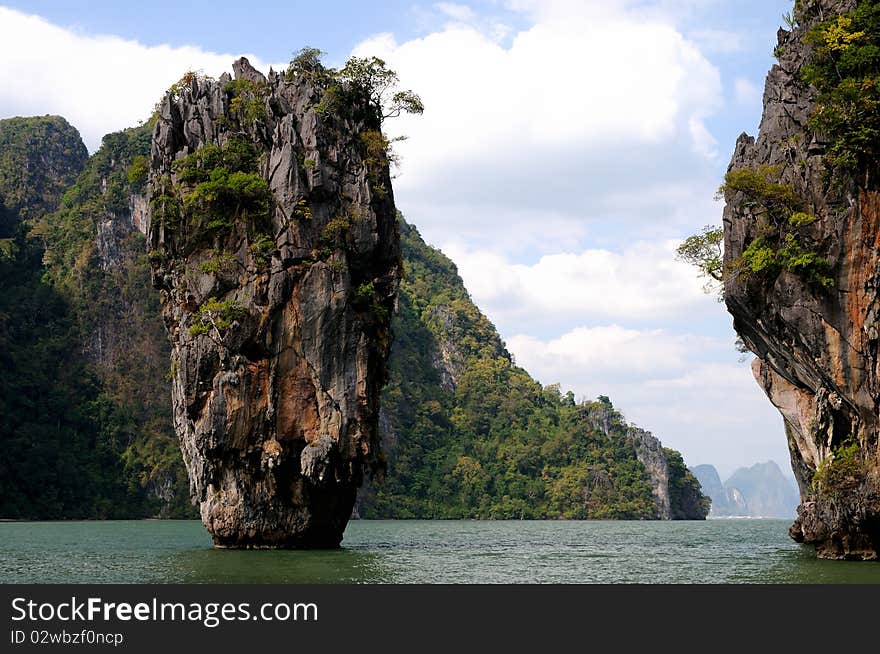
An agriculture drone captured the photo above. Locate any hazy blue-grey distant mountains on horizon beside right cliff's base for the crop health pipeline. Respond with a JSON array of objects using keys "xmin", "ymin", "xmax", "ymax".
[{"xmin": 691, "ymin": 461, "xmax": 800, "ymax": 518}]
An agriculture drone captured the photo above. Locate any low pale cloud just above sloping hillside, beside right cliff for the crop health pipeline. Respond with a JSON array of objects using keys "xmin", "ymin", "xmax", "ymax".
[{"xmin": 507, "ymin": 325, "xmax": 788, "ymax": 476}]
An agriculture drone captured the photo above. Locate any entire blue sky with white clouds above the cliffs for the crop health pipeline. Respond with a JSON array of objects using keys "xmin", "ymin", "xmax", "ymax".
[{"xmin": 0, "ymin": 0, "xmax": 792, "ymax": 477}]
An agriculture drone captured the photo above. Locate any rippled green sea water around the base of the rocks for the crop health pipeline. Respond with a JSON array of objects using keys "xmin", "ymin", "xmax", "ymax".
[{"xmin": 0, "ymin": 520, "xmax": 880, "ymax": 584}]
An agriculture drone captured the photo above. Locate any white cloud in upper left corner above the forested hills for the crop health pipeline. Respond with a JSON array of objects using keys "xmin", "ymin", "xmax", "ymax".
[{"xmin": 0, "ymin": 7, "xmax": 276, "ymax": 150}]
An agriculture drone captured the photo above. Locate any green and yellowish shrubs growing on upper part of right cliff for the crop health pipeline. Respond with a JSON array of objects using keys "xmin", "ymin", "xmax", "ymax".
[{"xmin": 678, "ymin": 0, "xmax": 880, "ymax": 289}]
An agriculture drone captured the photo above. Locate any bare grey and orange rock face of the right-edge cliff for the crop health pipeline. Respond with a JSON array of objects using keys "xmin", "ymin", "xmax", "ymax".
[{"xmin": 724, "ymin": 0, "xmax": 880, "ymax": 559}]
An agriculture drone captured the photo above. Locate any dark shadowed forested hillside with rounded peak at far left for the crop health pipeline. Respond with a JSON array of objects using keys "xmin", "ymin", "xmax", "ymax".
[{"xmin": 0, "ymin": 117, "xmax": 149, "ymax": 518}]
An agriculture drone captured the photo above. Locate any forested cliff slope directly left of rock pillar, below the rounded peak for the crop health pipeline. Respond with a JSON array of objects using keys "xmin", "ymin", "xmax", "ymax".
[{"xmin": 0, "ymin": 123, "xmax": 191, "ymax": 518}]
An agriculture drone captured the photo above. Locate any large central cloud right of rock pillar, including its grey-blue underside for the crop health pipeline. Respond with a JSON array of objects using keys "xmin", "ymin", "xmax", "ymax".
[{"xmin": 354, "ymin": 2, "xmax": 722, "ymax": 249}]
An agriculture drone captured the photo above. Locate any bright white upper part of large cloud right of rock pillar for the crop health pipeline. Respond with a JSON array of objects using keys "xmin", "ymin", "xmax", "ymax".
[{"xmin": 364, "ymin": 17, "xmax": 720, "ymax": 169}]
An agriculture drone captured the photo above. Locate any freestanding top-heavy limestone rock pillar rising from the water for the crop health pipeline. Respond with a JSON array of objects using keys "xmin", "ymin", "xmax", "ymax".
[{"xmin": 148, "ymin": 59, "xmax": 400, "ymax": 547}]
